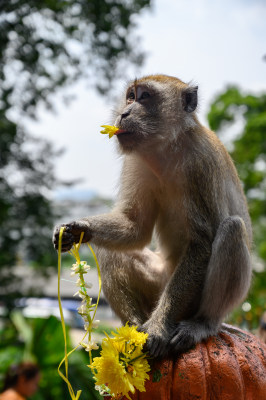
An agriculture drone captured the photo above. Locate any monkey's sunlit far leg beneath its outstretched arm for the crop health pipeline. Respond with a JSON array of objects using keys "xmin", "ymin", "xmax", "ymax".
[{"xmin": 96, "ymin": 248, "xmax": 167, "ymax": 326}]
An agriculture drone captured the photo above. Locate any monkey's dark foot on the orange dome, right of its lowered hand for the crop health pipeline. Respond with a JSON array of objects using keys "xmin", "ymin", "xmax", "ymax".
[{"xmin": 169, "ymin": 320, "xmax": 218, "ymax": 354}]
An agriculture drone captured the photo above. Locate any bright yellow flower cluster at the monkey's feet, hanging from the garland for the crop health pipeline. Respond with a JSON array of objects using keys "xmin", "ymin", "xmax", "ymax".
[{"xmin": 90, "ymin": 325, "xmax": 150, "ymax": 399}]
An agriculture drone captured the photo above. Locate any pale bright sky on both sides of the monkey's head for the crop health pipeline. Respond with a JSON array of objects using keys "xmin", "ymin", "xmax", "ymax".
[{"xmin": 25, "ymin": 0, "xmax": 266, "ymax": 198}]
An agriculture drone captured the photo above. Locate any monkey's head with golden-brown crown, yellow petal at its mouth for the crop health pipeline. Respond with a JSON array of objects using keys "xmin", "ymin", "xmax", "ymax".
[{"xmin": 115, "ymin": 75, "xmax": 198, "ymax": 153}]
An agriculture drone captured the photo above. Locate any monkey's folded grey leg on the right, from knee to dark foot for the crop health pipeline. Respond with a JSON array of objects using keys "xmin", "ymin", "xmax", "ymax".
[{"xmin": 170, "ymin": 216, "xmax": 251, "ymax": 352}]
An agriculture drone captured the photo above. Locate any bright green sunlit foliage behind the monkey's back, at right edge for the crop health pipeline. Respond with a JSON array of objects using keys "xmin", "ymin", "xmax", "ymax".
[{"xmin": 208, "ymin": 86, "xmax": 266, "ymax": 328}]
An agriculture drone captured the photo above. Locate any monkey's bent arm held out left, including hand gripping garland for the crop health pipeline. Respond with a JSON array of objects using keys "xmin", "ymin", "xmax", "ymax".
[{"xmin": 54, "ymin": 162, "xmax": 157, "ymax": 251}]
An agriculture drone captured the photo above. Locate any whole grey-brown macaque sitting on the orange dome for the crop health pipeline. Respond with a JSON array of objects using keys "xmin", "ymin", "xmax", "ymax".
[{"xmin": 54, "ymin": 75, "xmax": 252, "ymax": 357}]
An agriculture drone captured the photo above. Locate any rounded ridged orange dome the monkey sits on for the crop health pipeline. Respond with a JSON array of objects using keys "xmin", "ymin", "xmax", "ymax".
[{"xmin": 118, "ymin": 325, "xmax": 266, "ymax": 400}]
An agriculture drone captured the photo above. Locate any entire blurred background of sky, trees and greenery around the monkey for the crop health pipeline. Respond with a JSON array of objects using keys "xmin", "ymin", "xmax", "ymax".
[{"xmin": 0, "ymin": 0, "xmax": 266, "ymax": 400}]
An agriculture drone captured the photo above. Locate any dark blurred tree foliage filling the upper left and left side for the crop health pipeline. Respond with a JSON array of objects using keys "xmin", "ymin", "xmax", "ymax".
[{"xmin": 0, "ymin": 0, "xmax": 150, "ymax": 299}]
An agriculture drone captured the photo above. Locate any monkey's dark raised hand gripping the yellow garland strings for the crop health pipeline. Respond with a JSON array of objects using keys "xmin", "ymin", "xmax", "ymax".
[{"xmin": 53, "ymin": 221, "xmax": 92, "ymax": 252}]
